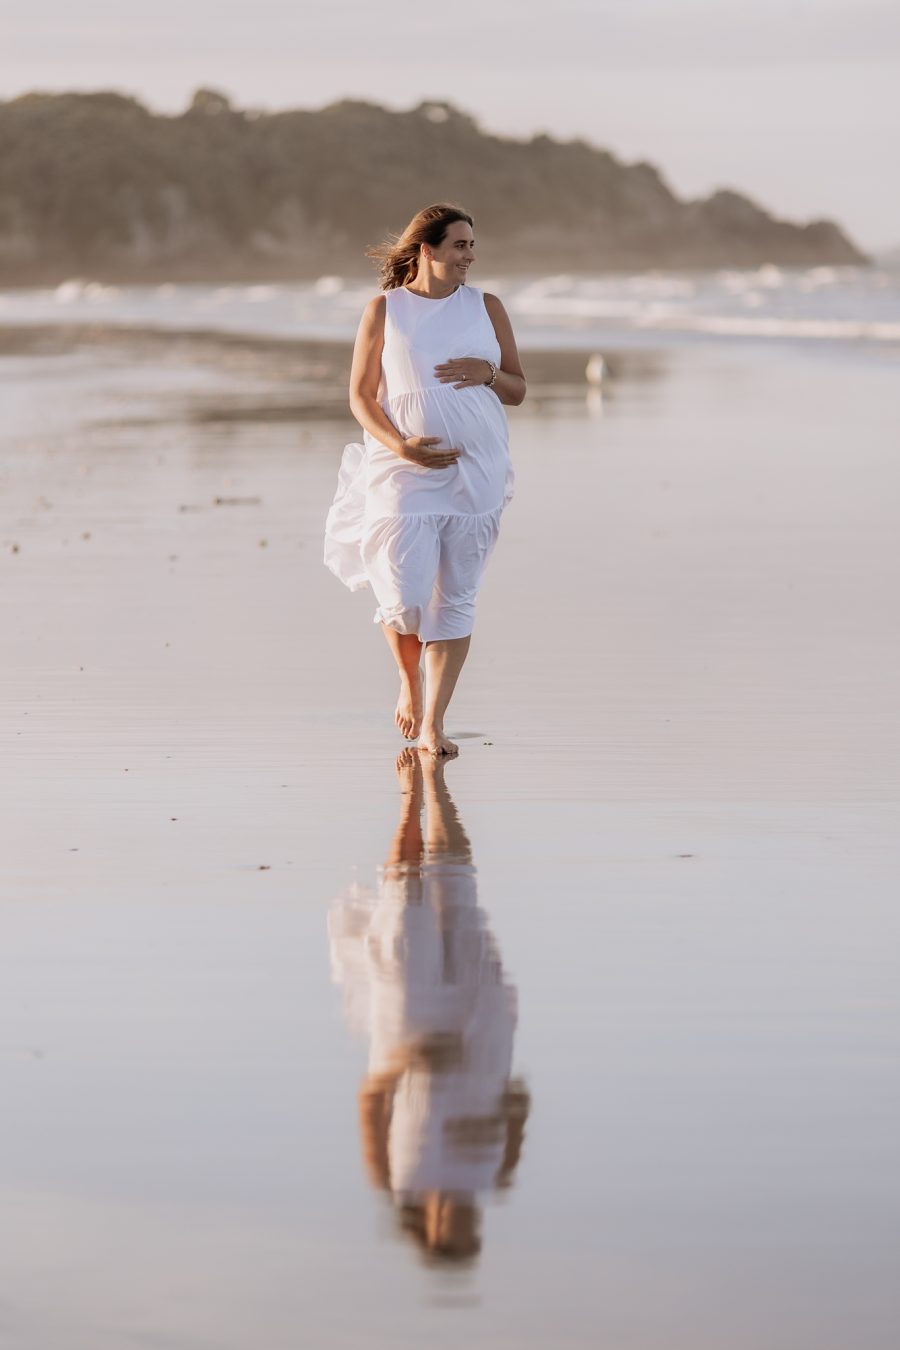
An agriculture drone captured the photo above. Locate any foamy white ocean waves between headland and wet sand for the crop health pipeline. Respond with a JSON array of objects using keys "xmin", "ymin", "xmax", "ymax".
[{"xmin": 0, "ymin": 265, "xmax": 900, "ymax": 347}]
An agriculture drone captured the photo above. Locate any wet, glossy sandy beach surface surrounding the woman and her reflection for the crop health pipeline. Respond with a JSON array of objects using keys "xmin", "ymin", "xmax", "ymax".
[{"xmin": 0, "ymin": 329, "xmax": 900, "ymax": 1350}]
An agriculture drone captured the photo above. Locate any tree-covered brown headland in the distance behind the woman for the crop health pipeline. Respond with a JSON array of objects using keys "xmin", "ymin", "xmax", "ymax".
[{"xmin": 0, "ymin": 89, "xmax": 869, "ymax": 286}]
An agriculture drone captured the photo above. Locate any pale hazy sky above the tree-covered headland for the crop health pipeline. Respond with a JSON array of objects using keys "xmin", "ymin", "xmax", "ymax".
[{"xmin": 7, "ymin": 0, "xmax": 900, "ymax": 248}]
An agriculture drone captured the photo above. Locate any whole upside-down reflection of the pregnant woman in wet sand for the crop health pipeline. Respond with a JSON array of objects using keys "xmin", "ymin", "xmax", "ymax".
[{"xmin": 329, "ymin": 749, "xmax": 528, "ymax": 1260}]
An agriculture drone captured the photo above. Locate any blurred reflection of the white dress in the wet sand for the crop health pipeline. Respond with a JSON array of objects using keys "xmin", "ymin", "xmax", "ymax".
[{"xmin": 329, "ymin": 861, "xmax": 515, "ymax": 1193}]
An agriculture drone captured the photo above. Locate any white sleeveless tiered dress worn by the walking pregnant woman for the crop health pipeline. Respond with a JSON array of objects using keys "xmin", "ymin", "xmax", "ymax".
[{"xmin": 325, "ymin": 286, "xmax": 513, "ymax": 643}]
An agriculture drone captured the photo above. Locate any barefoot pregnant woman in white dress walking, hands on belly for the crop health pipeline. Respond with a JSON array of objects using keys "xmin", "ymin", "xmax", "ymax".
[{"xmin": 325, "ymin": 204, "xmax": 525, "ymax": 755}]
